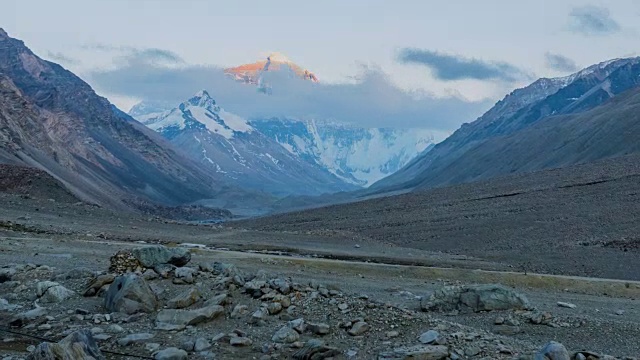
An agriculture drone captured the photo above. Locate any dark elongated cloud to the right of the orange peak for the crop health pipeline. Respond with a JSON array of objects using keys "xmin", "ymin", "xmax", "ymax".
[{"xmin": 397, "ymin": 48, "xmax": 530, "ymax": 82}]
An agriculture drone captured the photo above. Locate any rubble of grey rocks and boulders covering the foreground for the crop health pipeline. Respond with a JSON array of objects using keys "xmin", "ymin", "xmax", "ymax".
[{"xmin": 0, "ymin": 246, "xmax": 635, "ymax": 360}]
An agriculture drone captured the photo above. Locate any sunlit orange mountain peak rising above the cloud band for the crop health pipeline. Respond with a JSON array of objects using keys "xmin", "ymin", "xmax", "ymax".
[{"xmin": 224, "ymin": 53, "xmax": 318, "ymax": 85}]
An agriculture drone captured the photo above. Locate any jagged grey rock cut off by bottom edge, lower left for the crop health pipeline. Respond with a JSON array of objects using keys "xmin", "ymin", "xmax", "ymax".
[{"xmin": 27, "ymin": 330, "xmax": 105, "ymax": 360}]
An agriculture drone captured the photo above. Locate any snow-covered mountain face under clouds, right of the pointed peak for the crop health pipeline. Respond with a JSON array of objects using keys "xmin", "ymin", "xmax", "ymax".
[{"xmin": 250, "ymin": 119, "xmax": 434, "ymax": 186}]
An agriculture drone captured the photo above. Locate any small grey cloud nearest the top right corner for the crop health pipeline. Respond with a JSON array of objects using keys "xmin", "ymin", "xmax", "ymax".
[{"xmin": 569, "ymin": 5, "xmax": 621, "ymax": 36}]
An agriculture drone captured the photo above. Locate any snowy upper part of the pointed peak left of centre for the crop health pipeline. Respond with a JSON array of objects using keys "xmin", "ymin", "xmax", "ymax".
[{"xmin": 141, "ymin": 90, "xmax": 254, "ymax": 139}]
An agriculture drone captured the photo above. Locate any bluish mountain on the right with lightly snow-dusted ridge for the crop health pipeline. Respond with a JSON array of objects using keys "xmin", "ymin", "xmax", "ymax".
[{"xmin": 371, "ymin": 58, "xmax": 640, "ymax": 193}]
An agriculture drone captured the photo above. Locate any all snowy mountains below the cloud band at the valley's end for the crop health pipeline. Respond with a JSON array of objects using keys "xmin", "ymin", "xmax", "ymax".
[{"xmin": 130, "ymin": 90, "xmax": 433, "ymax": 196}]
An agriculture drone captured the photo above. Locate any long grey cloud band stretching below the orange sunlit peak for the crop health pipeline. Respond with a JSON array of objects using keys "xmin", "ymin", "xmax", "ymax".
[{"xmin": 87, "ymin": 53, "xmax": 492, "ymax": 132}]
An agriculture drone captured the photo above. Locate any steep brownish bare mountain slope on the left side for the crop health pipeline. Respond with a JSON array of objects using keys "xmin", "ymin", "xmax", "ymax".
[{"xmin": 0, "ymin": 29, "xmax": 246, "ymax": 209}]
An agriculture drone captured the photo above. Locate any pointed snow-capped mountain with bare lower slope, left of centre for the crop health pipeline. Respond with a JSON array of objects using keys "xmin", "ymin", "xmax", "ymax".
[{"xmin": 137, "ymin": 91, "xmax": 357, "ymax": 196}]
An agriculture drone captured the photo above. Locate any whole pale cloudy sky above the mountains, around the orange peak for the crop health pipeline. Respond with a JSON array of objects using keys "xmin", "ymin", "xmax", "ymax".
[{"xmin": 0, "ymin": 0, "xmax": 640, "ymax": 136}]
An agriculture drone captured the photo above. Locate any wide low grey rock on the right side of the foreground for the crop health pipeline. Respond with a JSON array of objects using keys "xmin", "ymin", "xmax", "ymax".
[{"xmin": 420, "ymin": 284, "xmax": 530, "ymax": 312}]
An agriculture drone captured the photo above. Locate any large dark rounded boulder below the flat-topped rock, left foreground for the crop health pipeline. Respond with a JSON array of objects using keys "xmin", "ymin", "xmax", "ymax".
[{"xmin": 104, "ymin": 274, "xmax": 158, "ymax": 314}]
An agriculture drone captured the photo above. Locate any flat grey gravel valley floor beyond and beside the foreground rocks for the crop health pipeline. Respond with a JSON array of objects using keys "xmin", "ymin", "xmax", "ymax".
[{"xmin": 0, "ymin": 194, "xmax": 640, "ymax": 359}]
